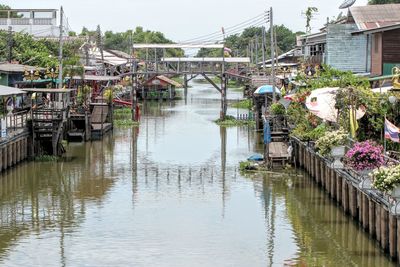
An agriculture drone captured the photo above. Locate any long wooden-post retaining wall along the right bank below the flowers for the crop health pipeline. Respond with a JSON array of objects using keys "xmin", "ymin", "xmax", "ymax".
[{"xmin": 293, "ymin": 139, "xmax": 400, "ymax": 263}]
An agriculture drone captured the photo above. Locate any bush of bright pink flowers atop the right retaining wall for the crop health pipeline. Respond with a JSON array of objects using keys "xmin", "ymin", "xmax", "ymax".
[{"xmin": 345, "ymin": 140, "xmax": 385, "ymax": 171}]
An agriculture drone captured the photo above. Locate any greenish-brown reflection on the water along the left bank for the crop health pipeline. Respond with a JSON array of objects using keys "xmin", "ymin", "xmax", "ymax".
[{"xmin": 0, "ymin": 136, "xmax": 114, "ymax": 262}]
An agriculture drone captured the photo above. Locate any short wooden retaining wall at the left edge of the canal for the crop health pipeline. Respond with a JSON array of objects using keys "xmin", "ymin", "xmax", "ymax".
[{"xmin": 0, "ymin": 132, "xmax": 30, "ymax": 174}]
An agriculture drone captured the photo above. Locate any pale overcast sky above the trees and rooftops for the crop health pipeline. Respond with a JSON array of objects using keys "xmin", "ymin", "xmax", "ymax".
[{"xmin": 4, "ymin": 0, "xmax": 368, "ymax": 41}]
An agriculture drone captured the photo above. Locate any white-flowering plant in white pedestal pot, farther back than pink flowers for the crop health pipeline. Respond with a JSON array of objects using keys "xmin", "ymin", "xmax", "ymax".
[{"xmin": 315, "ymin": 129, "xmax": 348, "ymax": 168}]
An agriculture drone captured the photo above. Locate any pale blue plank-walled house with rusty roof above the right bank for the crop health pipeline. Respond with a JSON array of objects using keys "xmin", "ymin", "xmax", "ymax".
[{"xmin": 298, "ymin": 4, "xmax": 400, "ymax": 76}]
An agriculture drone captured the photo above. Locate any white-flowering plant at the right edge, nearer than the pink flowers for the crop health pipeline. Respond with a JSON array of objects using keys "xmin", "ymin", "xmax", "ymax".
[{"xmin": 371, "ymin": 165, "xmax": 400, "ymax": 198}]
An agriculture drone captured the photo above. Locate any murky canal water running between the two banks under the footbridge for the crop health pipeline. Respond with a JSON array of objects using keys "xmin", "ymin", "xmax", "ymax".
[{"xmin": 0, "ymin": 80, "xmax": 394, "ymax": 267}]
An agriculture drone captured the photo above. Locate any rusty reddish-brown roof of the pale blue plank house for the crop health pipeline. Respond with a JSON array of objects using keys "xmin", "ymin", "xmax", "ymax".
[{"xmin": 350, "ymin": 4, "xmax": 400, "ymax": 30}]
